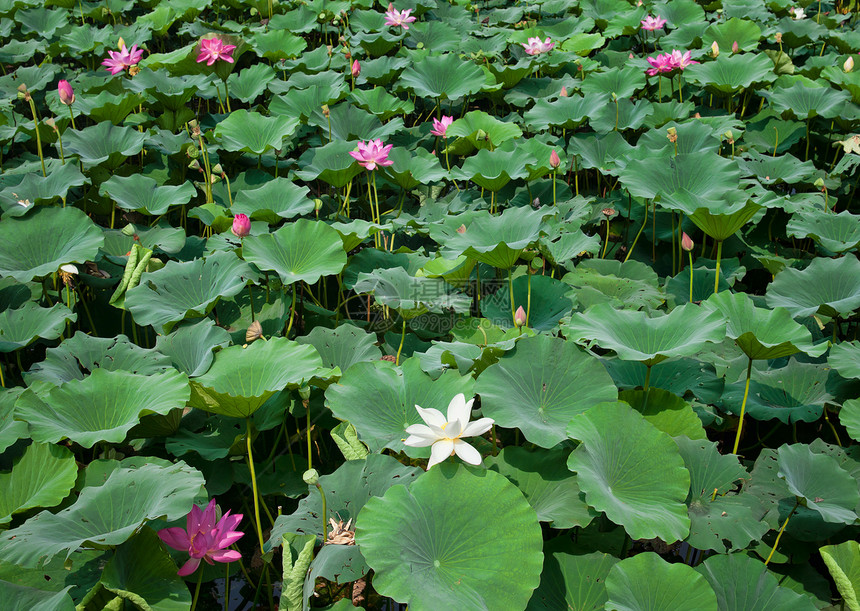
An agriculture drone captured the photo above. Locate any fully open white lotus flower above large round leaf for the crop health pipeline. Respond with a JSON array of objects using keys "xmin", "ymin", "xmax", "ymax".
[{"xmin": 403, "ymin": 393, "xmax": 494, "ymax": 470}]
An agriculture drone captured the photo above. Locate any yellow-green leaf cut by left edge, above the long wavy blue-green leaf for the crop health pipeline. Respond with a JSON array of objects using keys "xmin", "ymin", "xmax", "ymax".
[{"xmin": 0, "ymin": 443, "xmax": 78, "ymax": 524}]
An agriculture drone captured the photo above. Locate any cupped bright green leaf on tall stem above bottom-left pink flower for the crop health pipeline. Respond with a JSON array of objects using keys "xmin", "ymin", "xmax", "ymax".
[{"xmin": 189, "ymin": 337, "xmax": 331, "ymax": 418}]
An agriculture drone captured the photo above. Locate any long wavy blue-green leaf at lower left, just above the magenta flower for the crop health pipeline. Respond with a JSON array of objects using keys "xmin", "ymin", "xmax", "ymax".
[{"xmin": 0, "ymin": 461, "xmax": 203, "ymax": 567}]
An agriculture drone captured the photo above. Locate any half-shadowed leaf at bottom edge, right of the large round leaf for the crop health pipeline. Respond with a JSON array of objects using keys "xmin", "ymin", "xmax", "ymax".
[{"xmin": 526, "ymin": 549, "xmax": 618, "ymax": 611}]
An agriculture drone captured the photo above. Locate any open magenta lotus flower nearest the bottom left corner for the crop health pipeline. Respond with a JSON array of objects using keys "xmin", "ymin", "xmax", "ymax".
[{"xmin": 158, "ymin": 499, "xmax": 245, "ymax": 577}]
